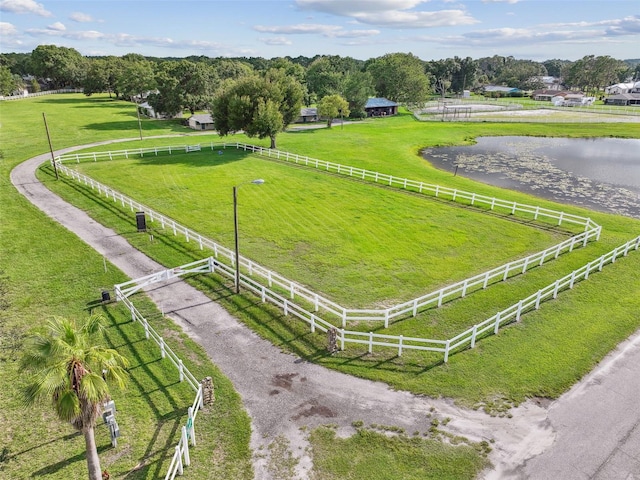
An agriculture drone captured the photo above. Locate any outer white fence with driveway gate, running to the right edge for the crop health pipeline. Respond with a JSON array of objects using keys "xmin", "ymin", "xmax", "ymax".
[{"xmin": 115, "ymin": 236, "xmax": 640, "ymax": 362}]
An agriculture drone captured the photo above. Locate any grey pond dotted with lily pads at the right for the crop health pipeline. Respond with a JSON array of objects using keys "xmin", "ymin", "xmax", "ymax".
[{"xmin": 422, "ymin": 137, "xmax": 640, "ymax": 218}]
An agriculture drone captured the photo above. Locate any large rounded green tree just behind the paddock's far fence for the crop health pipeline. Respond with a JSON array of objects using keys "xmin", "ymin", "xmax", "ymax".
[{"xmin": 211, "ymin": 69, "xmax": 303, "ymax": 148}]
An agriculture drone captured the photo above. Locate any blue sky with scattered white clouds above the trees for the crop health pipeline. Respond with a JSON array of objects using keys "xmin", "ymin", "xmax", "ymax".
[{"xmin": 0, "ymin": 0, "xmax": 640, "ymax": 61}]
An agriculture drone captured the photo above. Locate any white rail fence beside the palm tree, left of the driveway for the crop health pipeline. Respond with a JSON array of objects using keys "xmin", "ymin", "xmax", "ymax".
[{"xmin": 115, "ymin": 285, "xmax": 203, "ymax": 480}]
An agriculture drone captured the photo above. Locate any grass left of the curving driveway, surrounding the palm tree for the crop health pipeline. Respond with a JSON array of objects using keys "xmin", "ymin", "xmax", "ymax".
[{"xmin": 0, "ymin": 95, "xmax": 252, "ymax": 479}]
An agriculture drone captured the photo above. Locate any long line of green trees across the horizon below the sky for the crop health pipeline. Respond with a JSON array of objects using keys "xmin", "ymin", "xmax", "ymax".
[{"xmin": 0, "ymin": 45, "xmax": 640, "ymax": 145}]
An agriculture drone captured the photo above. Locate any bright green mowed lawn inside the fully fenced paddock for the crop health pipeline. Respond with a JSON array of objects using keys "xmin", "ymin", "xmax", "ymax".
[{"xmin": 71, "ymin": 146, "xmax": 575, "ymax": 308}]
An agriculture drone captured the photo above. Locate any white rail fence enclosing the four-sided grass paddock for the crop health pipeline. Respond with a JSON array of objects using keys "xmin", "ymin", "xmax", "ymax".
[{"xmin": 56, "ymin": 143, "xmax": 602, "ymax": 328}]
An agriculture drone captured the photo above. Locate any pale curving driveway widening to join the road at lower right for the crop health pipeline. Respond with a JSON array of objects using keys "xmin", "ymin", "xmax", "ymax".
[{"xmin": 11, "ymin": 143, "xmax": 640, "ymax": 480}]
